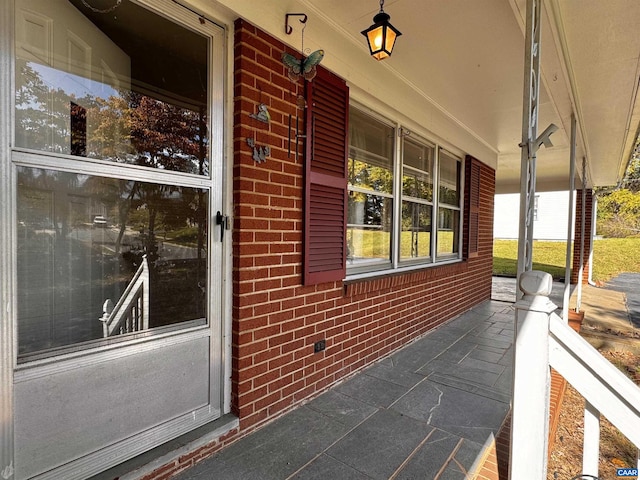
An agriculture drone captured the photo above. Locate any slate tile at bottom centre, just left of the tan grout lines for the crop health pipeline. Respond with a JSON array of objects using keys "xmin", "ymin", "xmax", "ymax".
[{"xmin": 326, "ymin": 410, "xmax": 432, "ymax": 480}]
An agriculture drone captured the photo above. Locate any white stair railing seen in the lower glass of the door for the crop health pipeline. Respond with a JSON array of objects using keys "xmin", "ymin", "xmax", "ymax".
[{"xmin": 99, "ymin": 255, "xmax": 149, "ymax": 337}]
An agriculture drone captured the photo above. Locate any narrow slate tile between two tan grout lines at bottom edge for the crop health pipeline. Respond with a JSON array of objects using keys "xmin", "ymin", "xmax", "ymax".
[{"xmin": 395, "ymin": 428, "xmax": 462, "ymax": 480}]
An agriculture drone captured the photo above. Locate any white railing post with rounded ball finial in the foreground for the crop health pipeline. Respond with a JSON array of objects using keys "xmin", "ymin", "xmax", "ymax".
[{"xmin": 509, "ymin": 270, "xmax": 557, "ymax": 480}]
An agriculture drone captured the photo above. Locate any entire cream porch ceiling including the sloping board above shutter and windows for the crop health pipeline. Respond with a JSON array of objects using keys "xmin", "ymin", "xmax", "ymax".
[{"xmin": 209, "ymin": 0, "xmax": 640, "ymax": 193}]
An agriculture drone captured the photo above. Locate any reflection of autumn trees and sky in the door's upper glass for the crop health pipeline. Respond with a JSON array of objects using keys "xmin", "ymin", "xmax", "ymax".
[{"xmin": 16, "ymin": 59, "xmax": 209, "ymax": 175}]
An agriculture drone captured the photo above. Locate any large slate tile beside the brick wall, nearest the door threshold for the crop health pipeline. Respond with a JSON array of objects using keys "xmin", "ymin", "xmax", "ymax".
[{"xmin": 176, "ymin": 407, "xmax": 349, "ymax": 480}]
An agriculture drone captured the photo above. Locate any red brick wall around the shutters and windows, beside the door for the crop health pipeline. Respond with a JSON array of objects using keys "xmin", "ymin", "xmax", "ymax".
[{"xmin": 232, "ymin": 21, "xmax": 495, "ymax": 430}]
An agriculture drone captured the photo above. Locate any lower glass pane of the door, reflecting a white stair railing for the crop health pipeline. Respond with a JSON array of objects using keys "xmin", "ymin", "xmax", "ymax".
[{"xmin": 17, "ymin": 167, "xmax": 209, "ymax": 355}]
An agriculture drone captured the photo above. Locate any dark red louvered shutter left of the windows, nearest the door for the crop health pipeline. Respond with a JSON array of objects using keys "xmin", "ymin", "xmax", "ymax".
[{"xmin": 303, "ymin": 68, "xmax": 349, "ymax": 285}]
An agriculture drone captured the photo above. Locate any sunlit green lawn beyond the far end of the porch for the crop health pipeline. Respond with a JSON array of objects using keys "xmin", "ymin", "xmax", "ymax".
[{"xmin": 493, "ymin": 238, "xmax": 640, "ymax": 282}]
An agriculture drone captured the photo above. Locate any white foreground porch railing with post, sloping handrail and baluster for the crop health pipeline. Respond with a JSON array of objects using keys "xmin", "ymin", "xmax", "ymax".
[{"xmin": 509, "ymin": 271, "xmax": 640, "ymax": 480}]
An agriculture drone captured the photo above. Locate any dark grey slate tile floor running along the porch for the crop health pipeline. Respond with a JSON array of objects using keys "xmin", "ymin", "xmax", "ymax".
[{"xmin": 175, "ymin": 301, "xmax": 515, "ymax": 480}]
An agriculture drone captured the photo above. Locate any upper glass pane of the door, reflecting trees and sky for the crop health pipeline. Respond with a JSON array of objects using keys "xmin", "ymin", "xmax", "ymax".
[{"xmin": 15, "ymin": 0, "xmax": 209, "ymax": 175}]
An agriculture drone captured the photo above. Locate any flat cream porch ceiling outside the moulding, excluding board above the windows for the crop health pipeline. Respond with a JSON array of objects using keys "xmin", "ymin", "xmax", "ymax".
[{"xmin": 301, "ymin": 0, "xmax": 640, "ymax": 192}]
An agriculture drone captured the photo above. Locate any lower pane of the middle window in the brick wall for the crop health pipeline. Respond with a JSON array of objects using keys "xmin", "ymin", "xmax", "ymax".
[{"xmin": 400, "ymin": 202, "xmax": 432, "ymax": 260}]
